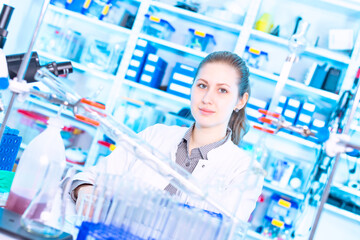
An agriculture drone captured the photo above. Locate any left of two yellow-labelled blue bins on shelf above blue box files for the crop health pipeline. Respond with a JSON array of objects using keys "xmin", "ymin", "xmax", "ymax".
[{"xmin": 142, "ymin": 14, "xmax": 175, "ymax": 40}]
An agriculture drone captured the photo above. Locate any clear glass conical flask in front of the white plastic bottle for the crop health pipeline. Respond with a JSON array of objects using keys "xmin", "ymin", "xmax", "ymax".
[{"xmin": 21, "ymin": 162, "xmax": 73, "ymax": 238}]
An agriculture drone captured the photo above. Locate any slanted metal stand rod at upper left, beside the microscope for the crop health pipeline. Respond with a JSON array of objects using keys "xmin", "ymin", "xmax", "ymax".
[{"xmin": 0, "ymin": 0, "xmax": 50, "ymax": 142}]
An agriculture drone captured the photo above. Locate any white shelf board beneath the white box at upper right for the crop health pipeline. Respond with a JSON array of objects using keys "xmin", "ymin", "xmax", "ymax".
[{"xmin": 251, "ymin": 29, "xmax": 351, "ymax": 64}]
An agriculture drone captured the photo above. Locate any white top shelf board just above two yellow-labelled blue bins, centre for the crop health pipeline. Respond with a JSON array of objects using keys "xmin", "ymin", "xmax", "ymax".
[{"xmin": 150, "ymin": 1, "xmax": 242, "ymax": 33}]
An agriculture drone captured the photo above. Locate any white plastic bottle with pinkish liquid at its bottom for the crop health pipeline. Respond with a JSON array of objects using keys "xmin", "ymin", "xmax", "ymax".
[{"xmin": 5, "ymin": 117, "xmax": 66, "ymax": 214}]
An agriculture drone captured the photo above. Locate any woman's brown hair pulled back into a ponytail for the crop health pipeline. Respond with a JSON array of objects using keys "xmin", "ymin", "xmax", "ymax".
[{"xmin": 195, "ymin": 51, "xmax": 250, "ymax": 145}]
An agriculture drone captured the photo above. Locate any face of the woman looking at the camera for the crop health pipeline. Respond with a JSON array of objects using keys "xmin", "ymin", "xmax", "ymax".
[{"xmin": 191, "ymin": 63, "xmax": 247, "ymax": 129}]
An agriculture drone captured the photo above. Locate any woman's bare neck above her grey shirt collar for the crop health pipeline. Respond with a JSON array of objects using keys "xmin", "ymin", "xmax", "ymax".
[{"xmin": 190, "ymin": 124, "xmax": 227, "ymax": 148}]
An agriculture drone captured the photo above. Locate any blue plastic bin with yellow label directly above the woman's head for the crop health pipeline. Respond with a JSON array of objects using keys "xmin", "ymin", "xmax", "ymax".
[{"xmin": 186, "ymin": 28, "xmax": 216, "ymax": 52}]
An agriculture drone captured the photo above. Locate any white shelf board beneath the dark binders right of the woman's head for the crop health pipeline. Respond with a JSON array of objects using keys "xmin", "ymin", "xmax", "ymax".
[{"xmin": 249, "ymin": 67, "xmax": 339, "ymax": 102}]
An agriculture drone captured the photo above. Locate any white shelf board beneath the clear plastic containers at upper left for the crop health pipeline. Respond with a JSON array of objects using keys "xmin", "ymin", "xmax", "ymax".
[{"xmin": 36, "ymin": 51, "xmax": 115, "ymax": 81}]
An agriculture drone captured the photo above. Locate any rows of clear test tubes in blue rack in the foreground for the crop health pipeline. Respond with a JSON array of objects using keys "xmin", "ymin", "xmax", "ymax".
[{"xmin": 77, "ymin": 174, "xmax": 235, "ymax": 240}]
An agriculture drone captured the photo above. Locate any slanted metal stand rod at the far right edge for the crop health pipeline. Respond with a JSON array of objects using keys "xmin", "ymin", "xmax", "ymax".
[{"xmin": 309, "ymin": 74, "xmax": 360, "ymax": 240}]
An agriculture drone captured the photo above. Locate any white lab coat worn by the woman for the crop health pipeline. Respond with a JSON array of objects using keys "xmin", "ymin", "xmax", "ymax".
[{"xmin": 73, "ymin": 124, "xmax": 263, "ymax": 221}]
